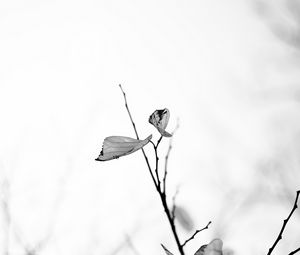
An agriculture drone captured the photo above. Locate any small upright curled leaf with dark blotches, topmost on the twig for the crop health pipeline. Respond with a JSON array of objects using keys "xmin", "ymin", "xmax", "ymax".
[{"xmin": 149, "ymin": 108, "xmax": 172, "ymax": 137}]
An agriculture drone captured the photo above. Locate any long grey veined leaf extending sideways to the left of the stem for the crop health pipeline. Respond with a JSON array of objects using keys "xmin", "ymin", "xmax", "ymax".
[{"xmin": 95, "ymin": 135, "xmax": 152, "ymax": 161}]
